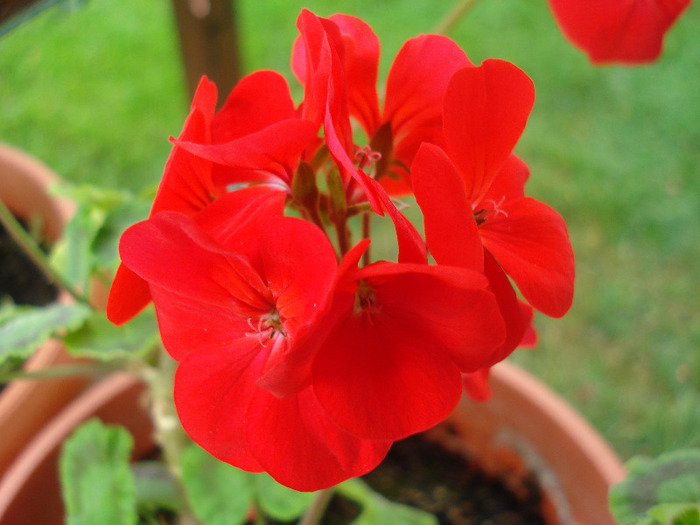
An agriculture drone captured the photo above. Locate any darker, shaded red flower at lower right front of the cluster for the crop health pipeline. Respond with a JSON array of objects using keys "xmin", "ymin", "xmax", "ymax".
[{"xmin": 260, "ymin": 242, "xmax": 505, "ymax": 440}]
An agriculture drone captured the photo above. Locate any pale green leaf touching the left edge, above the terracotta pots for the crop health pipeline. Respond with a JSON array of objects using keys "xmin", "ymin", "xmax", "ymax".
[{"xmin": 0, "ymin": 303, "xmax": 92, "ymax": 363}]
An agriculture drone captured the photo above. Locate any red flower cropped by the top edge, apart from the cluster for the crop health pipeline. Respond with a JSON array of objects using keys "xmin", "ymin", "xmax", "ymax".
[{"xmin": 549, "ymin": 0, "xmax": 690, "ymax": 64}]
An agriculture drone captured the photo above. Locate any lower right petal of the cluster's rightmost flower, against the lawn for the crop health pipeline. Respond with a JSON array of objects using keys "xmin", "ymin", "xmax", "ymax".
[{"xmin": 479, "ymin": 197, "xmax": 574, "ymax": 317}]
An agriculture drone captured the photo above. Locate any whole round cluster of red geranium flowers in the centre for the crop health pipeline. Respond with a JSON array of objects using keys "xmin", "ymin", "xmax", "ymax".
[{"xmin": 108, "ymin": 11, "xmax": 574, "ymax": 491}]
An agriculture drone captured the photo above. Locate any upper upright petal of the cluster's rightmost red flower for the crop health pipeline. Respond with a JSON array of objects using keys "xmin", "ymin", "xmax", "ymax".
[{"xmin": 444, "ymin": 60, "xmax": 535, "ymax": 204}]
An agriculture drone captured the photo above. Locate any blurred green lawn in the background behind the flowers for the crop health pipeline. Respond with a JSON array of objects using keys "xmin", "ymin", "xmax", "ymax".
[{"xmin": 0, "ymin": 0, "xmax": 700, "ymax": 458}]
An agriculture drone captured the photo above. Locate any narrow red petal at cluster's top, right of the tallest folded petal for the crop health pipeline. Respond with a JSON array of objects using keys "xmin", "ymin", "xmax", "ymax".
[{"xmin": 329, "ymin": 15, "xmax": 379, "ymax": 137}]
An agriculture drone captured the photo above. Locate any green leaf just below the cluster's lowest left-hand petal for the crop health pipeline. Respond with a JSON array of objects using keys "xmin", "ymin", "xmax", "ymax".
[{"xmin": 63, "ymin": 308, "xmax": 160, "ymax": 361}]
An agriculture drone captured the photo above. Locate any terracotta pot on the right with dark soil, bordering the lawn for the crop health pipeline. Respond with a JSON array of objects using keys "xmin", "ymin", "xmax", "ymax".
[{"xmin": 427, "ymin": 362, "xmax": 625, "ymax": 525}]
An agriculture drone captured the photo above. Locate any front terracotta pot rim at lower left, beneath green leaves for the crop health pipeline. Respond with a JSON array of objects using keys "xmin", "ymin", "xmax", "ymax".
[{"xmin": 0, "ymin": 372, "xmax": 154, "ymax": 525}]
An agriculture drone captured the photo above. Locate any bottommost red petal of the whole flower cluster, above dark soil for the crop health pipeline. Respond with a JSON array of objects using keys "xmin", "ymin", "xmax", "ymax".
[{"xmin": 247, "ymin": 387, "xmax": 391, "ymax": 491}]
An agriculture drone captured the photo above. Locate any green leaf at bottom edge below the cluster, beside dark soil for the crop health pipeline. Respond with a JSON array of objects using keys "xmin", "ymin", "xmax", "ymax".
[{"xmin": 338, "ymin": 478, "xmax": 438, "ymax": 525}]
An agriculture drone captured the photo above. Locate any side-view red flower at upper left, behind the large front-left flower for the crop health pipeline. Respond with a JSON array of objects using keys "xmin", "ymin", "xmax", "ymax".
[{"xmin": 107, "ymin": 71, "xmax": 314, "ymax": 324}]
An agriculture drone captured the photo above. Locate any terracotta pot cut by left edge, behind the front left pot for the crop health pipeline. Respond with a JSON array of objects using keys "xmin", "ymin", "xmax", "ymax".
[{"xmin": 0, "ymin": 144, "xmax": 87, "ymax": 476}]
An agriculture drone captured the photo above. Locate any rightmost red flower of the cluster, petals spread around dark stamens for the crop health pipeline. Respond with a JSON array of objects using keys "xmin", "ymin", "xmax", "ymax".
[{"xmin": 411, "ymin": 60, "xmax": 574, "ymax": 320}]
